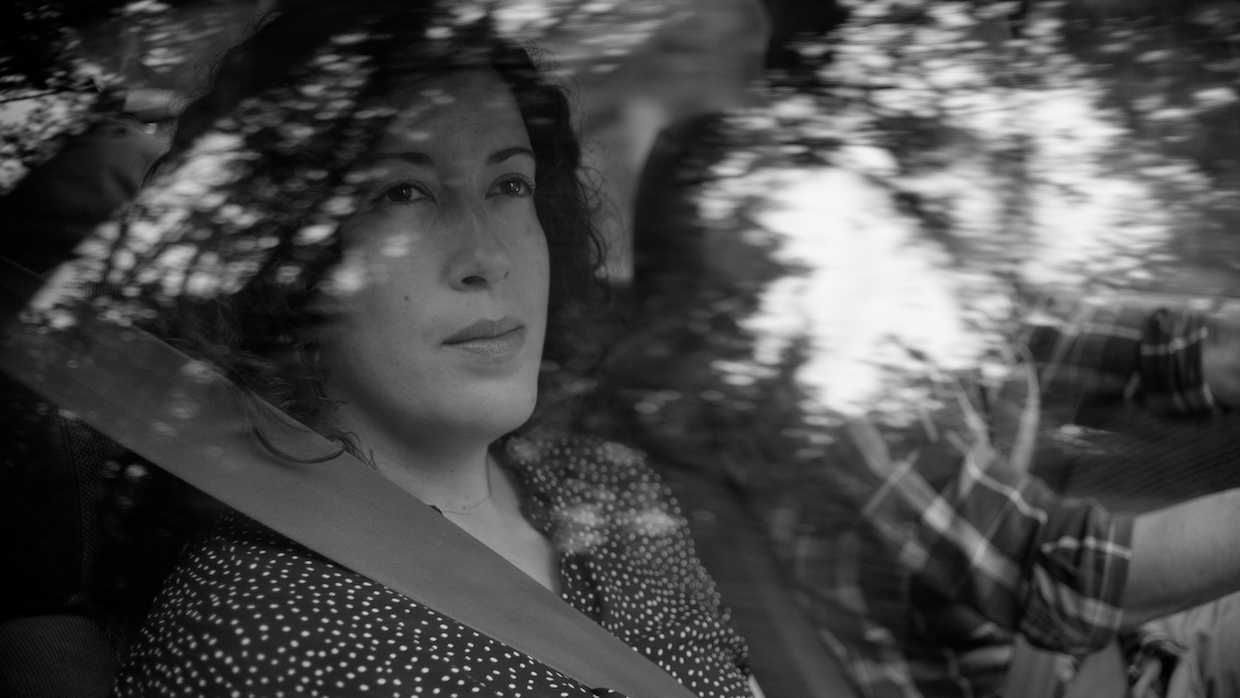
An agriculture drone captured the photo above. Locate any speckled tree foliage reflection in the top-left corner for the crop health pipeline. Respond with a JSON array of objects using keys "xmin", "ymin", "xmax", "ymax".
[{"xmin": 0, "ymin": 0, "xmax": 255, "ymax": 188}]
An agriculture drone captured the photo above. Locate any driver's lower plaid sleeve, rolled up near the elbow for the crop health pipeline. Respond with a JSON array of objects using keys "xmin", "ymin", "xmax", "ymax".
[{"xmin": 848, "ymin": 423, "xmax": 1133, "ymax": 653}]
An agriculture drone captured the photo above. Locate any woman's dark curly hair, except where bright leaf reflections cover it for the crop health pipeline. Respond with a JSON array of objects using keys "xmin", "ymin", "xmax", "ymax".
[{"xmin": 141, "ymin": 0, "xmax": 604, "ymax": 446}]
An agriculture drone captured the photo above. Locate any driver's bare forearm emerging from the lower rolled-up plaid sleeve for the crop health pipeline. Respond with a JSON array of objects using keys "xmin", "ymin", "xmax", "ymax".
[{"xmin": 1123, "ymin": 490, "xmax": 1240, "ymax": 627}]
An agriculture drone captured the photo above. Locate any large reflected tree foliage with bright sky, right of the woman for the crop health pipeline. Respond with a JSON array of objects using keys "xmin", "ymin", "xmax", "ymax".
[{"xmin": 585, "ymin": 0, "xmax": 1240, "ymax": 485}]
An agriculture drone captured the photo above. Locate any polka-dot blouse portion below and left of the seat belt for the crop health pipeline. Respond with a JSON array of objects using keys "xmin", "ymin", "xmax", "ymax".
[{"xmin": 114, "ymin": 515, "xmax": 610, "ymax": 698}]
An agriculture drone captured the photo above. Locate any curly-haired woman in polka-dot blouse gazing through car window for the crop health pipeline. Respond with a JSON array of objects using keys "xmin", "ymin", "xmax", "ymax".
[{"xmin": 33, "ymin": 1, "xmax": 749, "ymax": 696}]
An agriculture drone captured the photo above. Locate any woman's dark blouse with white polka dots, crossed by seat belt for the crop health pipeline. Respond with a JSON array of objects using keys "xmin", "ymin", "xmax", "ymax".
[{"xmin": 114, "ymin": 435, "xmax": 750, "ymax": 697}]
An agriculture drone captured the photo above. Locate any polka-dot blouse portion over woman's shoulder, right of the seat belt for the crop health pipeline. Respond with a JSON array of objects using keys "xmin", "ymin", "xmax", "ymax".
[{"xmin": 503, "ymin": 431, "xmax": 746, "ymax": 694}]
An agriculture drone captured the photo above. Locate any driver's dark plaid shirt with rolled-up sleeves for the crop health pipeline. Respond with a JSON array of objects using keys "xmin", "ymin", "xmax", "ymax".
[{"xmin": 771, "ymin": 300, "xmax": 1213, "ymax": 698}]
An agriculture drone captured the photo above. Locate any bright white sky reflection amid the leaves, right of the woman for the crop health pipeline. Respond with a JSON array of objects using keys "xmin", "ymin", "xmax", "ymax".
[{"xmin": 724, "ymin": 81, "xmax": 1176, "ymax": 414}]
